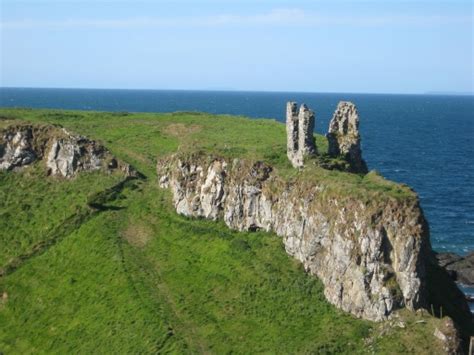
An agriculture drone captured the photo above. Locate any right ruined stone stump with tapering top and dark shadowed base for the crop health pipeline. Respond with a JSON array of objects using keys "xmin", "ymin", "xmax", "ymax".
[{"xmin": 326, "ymin": 101, "xmax": 367, "ymax": 173}]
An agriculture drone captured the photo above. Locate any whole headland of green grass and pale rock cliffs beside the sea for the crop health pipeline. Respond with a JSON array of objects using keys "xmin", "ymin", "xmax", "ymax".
[{"xmin": 0, "ymin": 106, "xmax": 473, "ymax": 354}]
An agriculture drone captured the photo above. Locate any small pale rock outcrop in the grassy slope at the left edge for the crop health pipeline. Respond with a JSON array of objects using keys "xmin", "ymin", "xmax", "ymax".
[{"xmin": 0, "ymin": 124, "xmax": 136, "ymax": 178}]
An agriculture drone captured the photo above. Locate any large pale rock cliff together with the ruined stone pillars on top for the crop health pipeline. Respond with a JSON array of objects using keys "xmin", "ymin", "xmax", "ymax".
[{"xmin": 157, "ymin": 102, "xmax": 469, "ymax": 334}]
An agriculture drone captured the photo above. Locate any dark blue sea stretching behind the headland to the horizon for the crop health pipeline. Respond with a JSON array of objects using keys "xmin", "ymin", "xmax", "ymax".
[{"xmin": 0, "ymin": 88, "xmax": 474, "ymax": 254}]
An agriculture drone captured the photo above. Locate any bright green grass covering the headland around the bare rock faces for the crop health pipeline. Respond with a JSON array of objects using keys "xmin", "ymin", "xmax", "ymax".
[{"xmin": 0, "ymin": 110, "xmax": 450, "ymax": 354}]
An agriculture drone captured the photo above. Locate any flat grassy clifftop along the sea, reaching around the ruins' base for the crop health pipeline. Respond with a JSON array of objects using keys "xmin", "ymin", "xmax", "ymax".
[{"xmin": 0, "ymin": 109, "xmax": 416, "ymax": 199}]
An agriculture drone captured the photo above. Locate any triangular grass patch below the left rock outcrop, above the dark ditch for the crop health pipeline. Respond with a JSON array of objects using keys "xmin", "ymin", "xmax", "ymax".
[{"xmin": 0, "ymin": 166, "xmax": 121, "ymax": 267}]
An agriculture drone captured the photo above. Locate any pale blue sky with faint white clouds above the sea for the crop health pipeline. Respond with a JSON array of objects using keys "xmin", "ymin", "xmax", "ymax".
[{"xmin": 0, "ymin": 0, "xmax": 474, "ymax": 93}]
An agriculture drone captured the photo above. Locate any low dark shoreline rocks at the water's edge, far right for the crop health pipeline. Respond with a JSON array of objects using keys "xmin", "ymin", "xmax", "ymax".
[{"xmin": 436, "ymin": 253, "xmax": 474, "ymax": 285}]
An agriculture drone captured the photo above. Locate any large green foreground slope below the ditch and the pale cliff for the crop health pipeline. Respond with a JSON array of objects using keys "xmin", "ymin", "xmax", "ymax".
[{"xmin": 0, "ymin": 182, "xmax": 450, "ymax": 353}]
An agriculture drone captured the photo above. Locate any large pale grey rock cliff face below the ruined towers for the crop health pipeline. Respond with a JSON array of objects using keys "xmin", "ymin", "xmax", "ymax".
[{"xmin": 157, "ymin": 157, "xmax": 430, "ymax": 321}]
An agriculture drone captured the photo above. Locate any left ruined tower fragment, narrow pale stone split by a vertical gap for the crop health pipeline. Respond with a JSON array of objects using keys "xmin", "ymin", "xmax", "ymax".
[{"xmin": 286, "ymin": 102, "xmax": 317, "ymax": 168}]
